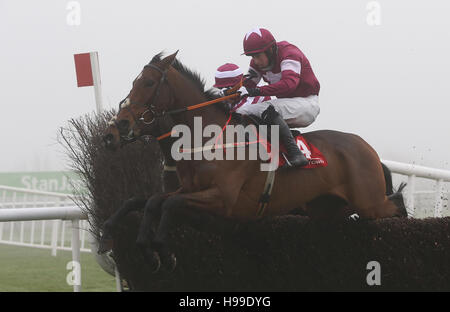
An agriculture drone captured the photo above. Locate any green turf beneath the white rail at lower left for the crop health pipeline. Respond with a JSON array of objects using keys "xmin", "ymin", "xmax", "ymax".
[{"xmin": 0, "ymin": 244, "xmax": 116, "ymax": 292}]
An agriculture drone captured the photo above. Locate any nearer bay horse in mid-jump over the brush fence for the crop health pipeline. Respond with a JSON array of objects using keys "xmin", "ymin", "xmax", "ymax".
[{"xmin": 104, "ymin": 51, "xmax": 406, "ymax": 270}]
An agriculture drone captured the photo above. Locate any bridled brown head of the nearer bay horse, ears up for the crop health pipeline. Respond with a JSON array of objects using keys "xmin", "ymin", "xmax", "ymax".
[{"xmin": 103, "ymin": 51, "xmax": 178, "ymax": 150}]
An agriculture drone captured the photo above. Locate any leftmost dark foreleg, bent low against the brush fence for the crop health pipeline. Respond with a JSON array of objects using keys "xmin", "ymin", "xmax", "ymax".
[{"xmin": 98, "ymin": 198, "xmax": 147, "ymax": 254}]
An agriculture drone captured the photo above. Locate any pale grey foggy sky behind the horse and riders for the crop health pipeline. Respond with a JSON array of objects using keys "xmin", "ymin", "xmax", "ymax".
[{"xmin": 0, "ymin": 0, "xmax": 450, "ymax": 171}]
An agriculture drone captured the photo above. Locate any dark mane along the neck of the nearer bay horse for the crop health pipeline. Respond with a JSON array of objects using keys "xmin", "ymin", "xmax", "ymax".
[{"xmin": 150, "ymin": 52, "xmax": 230, "ymax": 114}]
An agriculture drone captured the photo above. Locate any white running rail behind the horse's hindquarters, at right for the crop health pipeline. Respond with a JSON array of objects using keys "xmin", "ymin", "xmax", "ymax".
[{"xmin": 381, "ymin": 159, "xmax": 450, "ymax": 217}]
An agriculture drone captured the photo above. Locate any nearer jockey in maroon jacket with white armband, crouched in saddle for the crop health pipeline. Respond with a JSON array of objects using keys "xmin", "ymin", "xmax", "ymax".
[{"xmin": 239, "ymin": 28, "xmax": 320, "ymax": 167}]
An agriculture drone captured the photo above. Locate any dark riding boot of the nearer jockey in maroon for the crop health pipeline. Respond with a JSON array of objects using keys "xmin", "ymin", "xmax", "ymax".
[{"xmin": 262, "ymin": 105, "xmax": 309, "ymax": 167}]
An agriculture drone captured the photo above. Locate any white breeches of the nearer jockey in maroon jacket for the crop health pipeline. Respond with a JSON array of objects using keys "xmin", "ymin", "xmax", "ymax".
[{"xmin": 236, "ymin": 95, "xmax": 320, "ymax": 128}]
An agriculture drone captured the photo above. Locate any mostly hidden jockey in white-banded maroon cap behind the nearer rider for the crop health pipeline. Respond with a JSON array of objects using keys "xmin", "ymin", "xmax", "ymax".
[{"xmin": 213, "ymin": 63, "xmax": 275, "ymax": 115}]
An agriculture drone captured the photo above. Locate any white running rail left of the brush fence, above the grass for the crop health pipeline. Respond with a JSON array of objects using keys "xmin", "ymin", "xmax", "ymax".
[{"xmin": 0, "ymin": 185, "xmax": 91, "ymax": 292}]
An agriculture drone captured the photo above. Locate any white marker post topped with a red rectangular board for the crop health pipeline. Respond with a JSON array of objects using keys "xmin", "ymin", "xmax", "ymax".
[{"xmin": 74, "ymin": 52, "xmax": 103, "ymax": 114}]
